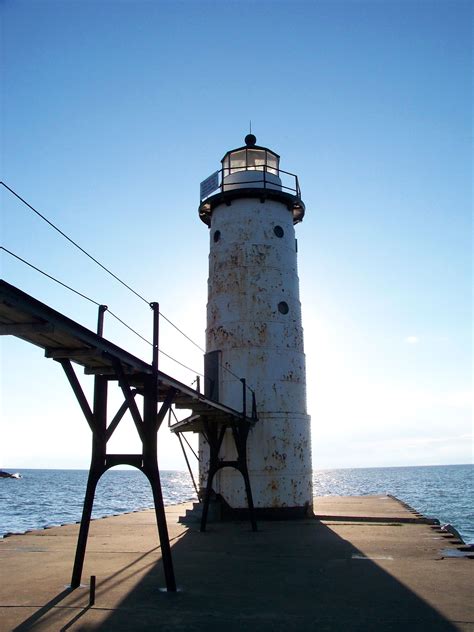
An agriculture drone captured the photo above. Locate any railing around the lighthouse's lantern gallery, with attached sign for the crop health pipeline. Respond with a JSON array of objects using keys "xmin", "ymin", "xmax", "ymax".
[{"xmin": 200, "ymin": 165, "xmax": 301, "ymax": 202}]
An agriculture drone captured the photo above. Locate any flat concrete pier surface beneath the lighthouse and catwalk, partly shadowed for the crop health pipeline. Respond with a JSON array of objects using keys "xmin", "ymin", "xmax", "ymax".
[{"xmin": 0, "ymin": 496, "xmax": 474, "ymax": 632}]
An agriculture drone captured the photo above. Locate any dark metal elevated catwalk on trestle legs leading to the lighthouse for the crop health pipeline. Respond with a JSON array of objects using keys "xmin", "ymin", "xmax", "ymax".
[{"xmin": 0, "ymin": 280, "xmax": 256, "ymax": 591}]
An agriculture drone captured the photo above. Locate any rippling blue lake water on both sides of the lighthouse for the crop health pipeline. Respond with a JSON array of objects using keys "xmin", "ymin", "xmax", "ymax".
[{"xmin": 0, "ymin": 465, "xmax": 474, "ymax": 543}]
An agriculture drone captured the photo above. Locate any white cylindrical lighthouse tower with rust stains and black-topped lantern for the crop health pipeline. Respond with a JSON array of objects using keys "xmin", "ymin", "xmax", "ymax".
[{"xmin": 199, "ymin": 134, "xmax": 312, "ymax": 517}]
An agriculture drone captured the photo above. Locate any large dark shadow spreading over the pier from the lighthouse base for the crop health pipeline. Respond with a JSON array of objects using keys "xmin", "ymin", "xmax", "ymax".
[{"xmin": 15, "ymin": 520, "xmax": 461, "ymax": 632}]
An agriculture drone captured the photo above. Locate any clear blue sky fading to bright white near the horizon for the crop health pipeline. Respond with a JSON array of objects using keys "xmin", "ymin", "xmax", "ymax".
[{"xmin": 0, "ymin": 0, "xmax": 473, "ymax": 469}]
